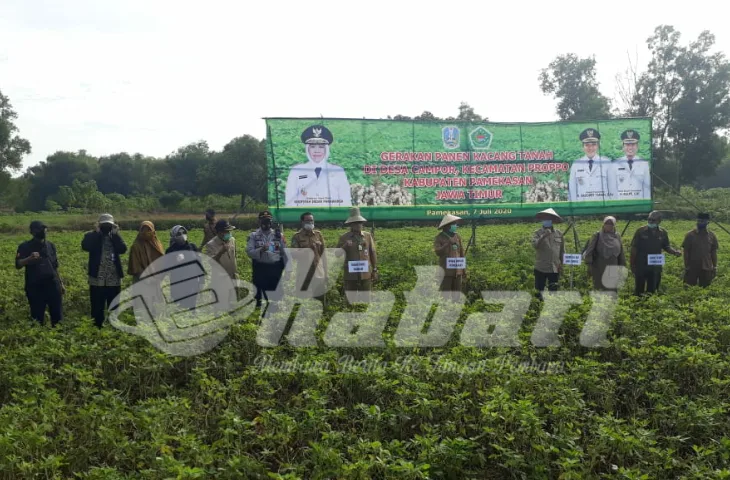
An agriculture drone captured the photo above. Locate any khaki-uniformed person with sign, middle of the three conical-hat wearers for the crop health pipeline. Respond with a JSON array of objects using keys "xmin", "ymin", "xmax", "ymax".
[{"xmin": 433, "ymin": 215, "xmax": 466, "ymax": 302}]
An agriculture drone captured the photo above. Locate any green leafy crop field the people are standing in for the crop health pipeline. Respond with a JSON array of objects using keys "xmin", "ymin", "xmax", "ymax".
[{"xmin": 0, "ymin": 222, "xmax": 730, "ymax": 479}]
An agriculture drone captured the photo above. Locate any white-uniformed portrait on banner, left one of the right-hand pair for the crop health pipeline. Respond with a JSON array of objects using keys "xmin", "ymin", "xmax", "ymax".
[{"xmin": 568, "ymin": 128, "xmax": 613, "ymax": 202}]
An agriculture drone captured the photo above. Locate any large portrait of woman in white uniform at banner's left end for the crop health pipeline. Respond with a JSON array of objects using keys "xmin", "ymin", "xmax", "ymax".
[{"xmin": 284, "ymin": 125, "xmax": 352, "ymax": 207}]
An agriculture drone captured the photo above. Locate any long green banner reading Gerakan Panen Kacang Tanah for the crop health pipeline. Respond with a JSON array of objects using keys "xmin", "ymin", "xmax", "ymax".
[{"xmin": 266, "ymin": 118, "xmax": 652, "ymax": 222}]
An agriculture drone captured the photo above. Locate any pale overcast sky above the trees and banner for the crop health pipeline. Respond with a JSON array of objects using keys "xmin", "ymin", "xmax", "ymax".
[{"xmin": 0, "ymin": 0, "xmax": 730, "ymax": 172}]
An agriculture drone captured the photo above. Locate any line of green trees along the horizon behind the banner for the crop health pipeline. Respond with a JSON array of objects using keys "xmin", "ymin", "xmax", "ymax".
[{"xmin": 0, "ymin": 25, "xmax": 730, "ymax": 211}]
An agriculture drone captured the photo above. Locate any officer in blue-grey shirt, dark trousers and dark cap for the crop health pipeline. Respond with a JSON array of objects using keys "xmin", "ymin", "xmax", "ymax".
[{"xmin": 246, "ymin": 210, "xmax": 286, "ymax": 307}]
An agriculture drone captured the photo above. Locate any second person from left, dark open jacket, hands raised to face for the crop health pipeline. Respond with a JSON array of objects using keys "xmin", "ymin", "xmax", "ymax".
[{"xmin": 81, "ymin": 213, "xmax": 127, "ymax": 328}]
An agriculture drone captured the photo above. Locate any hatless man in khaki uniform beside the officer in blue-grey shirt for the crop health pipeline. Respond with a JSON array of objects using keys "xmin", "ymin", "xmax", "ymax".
[{"xmin": 291, "ymin": 212, "xmax": 326, "ymax": 300}]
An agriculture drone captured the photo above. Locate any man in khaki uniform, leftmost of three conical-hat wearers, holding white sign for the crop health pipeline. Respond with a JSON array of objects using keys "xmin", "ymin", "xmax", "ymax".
[{"xmin": 337, "ymin": 207, "xmax": 378, "ymax": 300}]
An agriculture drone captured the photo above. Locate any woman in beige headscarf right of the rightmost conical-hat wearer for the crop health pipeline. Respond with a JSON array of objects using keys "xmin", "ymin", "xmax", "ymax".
[{"xmin": 583, "ymin": 217, "xmax": 626, "ymax": 290}]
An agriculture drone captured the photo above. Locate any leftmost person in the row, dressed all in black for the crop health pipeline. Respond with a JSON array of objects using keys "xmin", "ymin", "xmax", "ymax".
[{"xmin": 15, "ymin": 220, "xmax": 66, "ymax": 327}]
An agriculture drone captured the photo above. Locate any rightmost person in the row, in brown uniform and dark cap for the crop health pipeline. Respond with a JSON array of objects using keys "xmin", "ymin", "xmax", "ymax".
[{"xmin": 682, "ymin": 213, "xmax": 718, "ymax": 287}]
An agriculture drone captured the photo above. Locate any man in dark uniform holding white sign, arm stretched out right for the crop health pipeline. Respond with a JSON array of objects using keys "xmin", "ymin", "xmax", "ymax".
[{"xmin": 631, "ymin": 210, "xmax": 682, "ymax": 297}]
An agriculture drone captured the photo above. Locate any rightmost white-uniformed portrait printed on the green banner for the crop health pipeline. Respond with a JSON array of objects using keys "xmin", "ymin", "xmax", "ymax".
[{"xmin": 608, "ymin": 130, "xmax": 651, "ymax": 200}]
